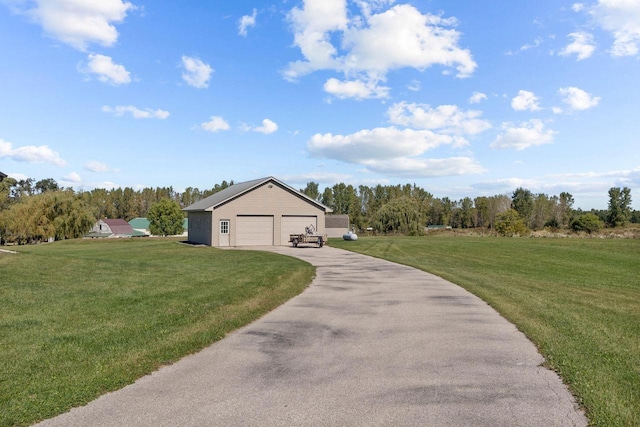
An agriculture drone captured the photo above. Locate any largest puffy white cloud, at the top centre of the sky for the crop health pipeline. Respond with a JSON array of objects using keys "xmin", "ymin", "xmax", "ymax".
[{"xmin": 284, "ymin": 0, "xmax": 476, "ymax": 98}]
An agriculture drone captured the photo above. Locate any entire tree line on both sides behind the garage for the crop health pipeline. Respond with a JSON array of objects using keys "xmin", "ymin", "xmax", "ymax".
[{"xmin": 0, "ymin": 178, "xmax": 640, "ymax": 244}]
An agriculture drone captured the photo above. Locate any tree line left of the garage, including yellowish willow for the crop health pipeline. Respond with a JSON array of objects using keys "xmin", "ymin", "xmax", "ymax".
[{"xmin": 0, "ymin": 178, "xmax": 233, "ymax": 244}]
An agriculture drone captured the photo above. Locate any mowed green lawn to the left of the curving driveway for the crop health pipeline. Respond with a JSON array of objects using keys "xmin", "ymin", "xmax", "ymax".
[{"xmin": 0, "ymin": 238, "xmax": 315, "ymax": 426}]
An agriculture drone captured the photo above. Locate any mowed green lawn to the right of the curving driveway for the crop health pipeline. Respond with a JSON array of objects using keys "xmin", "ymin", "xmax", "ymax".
[{"xmin": 330, "ymin": 236, "xmax": 640, "ymax": 426}]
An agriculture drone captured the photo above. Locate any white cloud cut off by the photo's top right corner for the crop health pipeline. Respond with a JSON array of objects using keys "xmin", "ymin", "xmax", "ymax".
[{"xmin": 590, "ymin": 0, "xmax": 640, "ymax": 56}]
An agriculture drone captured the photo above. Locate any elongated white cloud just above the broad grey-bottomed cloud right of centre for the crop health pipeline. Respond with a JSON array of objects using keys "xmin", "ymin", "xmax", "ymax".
[{"xmin": 387, "ymin": 102, "xmax": 491, "ymax": 135}]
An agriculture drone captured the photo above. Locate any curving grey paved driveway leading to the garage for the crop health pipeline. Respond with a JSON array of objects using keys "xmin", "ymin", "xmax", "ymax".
[{"xmin": 36, "ymin": 246, "xmax": 587, "ymax": 426}]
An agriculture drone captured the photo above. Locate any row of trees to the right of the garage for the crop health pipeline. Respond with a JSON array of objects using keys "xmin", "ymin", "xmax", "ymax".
[{"xmin": 300, "ymin": 182, "xmax": 640, "ymax": 234}]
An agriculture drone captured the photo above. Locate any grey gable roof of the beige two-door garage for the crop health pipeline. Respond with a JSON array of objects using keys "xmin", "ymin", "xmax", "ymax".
[{"xmin": 182, "ymin": 176, "xmax": 333, "ymax": 212}]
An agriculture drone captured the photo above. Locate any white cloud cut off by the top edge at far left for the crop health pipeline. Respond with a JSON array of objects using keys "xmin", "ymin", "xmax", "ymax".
[{"xmin": 5, "ymin": 0, "xmax": 135, "ymax": 51}]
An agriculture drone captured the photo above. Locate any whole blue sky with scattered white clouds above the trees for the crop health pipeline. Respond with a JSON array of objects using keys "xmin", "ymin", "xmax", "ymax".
[{"xmin": 0, "ymin": 0, "xmax": 640, "ymax": 209}]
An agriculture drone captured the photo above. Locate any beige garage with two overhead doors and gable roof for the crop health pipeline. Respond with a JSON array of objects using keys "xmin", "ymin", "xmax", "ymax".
[{"xmin": 183, "ymin": 177, "xmax": 332, "ymax": 247}]
